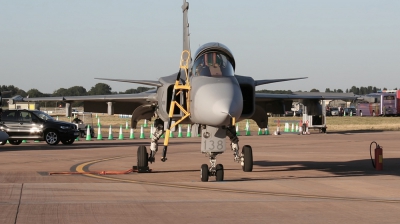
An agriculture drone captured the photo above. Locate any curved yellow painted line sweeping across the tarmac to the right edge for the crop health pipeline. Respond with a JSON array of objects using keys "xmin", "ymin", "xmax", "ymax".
[{"xmin": 76, "ymin": 156, "xmax": 400, "ymax": 203}]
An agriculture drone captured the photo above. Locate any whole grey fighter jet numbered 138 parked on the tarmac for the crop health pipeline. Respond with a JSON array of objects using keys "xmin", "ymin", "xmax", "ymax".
[{"xmin": 11, "ymin": 0, "xmax": 356, "ymax": 181}]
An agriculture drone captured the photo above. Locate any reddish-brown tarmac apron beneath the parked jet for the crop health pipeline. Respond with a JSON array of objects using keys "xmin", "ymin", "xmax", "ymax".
[{"xmin": 0, "ymin": 132, "xmax": 400, "ymax": 223}]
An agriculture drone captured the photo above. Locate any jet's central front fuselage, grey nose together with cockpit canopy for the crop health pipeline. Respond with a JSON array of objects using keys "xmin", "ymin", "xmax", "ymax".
[{"xmin": 189, "ymin": 43, "xmax": 243, "ymax": 126}]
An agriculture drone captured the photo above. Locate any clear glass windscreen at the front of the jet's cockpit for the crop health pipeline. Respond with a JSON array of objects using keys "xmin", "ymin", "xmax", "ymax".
[{"xmin": 191, "ymin": 51, "xmax": 235, "ymax": 77}]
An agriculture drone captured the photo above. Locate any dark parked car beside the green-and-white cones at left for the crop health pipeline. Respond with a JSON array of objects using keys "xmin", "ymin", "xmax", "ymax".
[{"xmin": 0, "ymin": 110, "xmax": 79, "ymax": 145}]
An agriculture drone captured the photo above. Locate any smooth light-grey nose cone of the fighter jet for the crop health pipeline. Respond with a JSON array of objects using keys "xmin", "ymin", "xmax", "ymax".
[{"xmin": 191, "ymin": 77, "xmax": 243, "ymax": 126}]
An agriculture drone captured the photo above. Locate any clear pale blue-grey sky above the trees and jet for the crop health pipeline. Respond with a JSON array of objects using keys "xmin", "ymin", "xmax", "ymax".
[{"xmin": 0, "ymin": 0, "xmax": 400, "ymax": 93}]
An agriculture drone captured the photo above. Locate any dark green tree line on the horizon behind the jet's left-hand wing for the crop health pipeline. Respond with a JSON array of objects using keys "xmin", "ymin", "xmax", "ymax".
[{"xmin": 0, "ymin": 83, "xmax": 154, "ymax": 107}]
